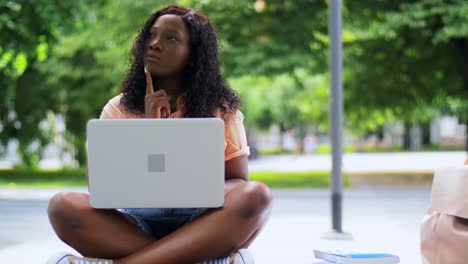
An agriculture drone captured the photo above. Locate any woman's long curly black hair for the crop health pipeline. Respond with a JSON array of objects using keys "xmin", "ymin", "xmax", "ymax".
[{"xmin": 121, "ymin": 5, "xmax": 241, "ymax": 117}]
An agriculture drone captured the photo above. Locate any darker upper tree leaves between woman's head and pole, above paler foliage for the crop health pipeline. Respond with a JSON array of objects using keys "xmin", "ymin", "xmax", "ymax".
[{"xmin": 192, "ymin": 0, "xmax": 328, "ymax": 77}]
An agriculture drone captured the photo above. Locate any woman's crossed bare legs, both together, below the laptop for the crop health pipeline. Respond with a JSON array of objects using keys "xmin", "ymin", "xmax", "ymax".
[{"xmin": 49, "ymin": 182, "xmax": 271, "ymax": 264}]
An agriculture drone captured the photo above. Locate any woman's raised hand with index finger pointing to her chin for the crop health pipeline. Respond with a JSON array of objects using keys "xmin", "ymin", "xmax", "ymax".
[{"xmin": 145, "ymin": 67, "xmax": 171, "ymax": 118}]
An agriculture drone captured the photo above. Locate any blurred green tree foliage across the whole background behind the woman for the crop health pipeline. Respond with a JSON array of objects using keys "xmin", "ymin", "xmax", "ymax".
[{"xmin": 0, "ymin": 0, "xmax": 468, "ymax": 166}]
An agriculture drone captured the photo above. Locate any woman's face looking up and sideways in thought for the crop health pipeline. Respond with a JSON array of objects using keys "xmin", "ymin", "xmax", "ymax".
[{"xmin": 144, "ymin": 15, "xmax": 190, "ymax": 78}]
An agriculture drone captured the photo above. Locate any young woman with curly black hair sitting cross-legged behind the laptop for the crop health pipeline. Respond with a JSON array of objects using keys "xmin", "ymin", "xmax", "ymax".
[{"xmin": 48, "ymin": 6, "xmax": 271, "ymax": 264}]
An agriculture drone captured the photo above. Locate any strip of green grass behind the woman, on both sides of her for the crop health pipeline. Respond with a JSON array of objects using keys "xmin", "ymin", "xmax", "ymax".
[{"xmin": 0, "ymin": 169, "xmax": 349, "ymax": 188}]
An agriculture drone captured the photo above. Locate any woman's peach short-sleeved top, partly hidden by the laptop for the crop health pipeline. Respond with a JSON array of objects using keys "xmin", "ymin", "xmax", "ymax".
[{"xmin": 100, "ymin": 94, "xmax": 250, "ymax": 161}]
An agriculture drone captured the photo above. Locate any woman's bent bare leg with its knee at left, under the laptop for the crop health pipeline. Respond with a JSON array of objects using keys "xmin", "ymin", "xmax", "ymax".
[{"xmin": 48, "ymin": 193, "xmax": 155, "ymax": 258}]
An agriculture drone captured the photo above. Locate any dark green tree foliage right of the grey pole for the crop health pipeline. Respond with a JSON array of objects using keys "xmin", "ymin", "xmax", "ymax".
[{"xmin": 345, "ymin": 0, "xmax": 468, "ymax": 150}]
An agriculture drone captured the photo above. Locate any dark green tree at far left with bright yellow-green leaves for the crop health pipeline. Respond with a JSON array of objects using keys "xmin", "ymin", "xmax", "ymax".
[{"xmin": 0, "ymin": 0, "xmax": 88, "ymax": 167}]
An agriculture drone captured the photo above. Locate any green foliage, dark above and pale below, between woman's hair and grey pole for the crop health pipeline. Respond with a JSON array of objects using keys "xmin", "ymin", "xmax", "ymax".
[{"xmin": 194, "ymin": 0, "xmax": 328, "ymax": 146}]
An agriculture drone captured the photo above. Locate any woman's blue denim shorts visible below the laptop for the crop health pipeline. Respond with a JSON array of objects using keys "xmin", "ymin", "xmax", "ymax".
[{"xmin": 120, "ymin": 208, "xmax": 208, "ymax": 239}]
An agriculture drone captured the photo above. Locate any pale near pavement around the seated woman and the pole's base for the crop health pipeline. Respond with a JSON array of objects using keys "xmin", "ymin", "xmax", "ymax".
[{"xmin": 0, "ymin": 186, "xmax": 430, "ymax": 264}]
